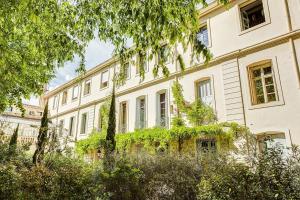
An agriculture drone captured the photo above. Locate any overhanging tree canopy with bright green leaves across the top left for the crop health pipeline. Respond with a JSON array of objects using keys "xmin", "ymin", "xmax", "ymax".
[{"xmin": 0, "ymin": 0, "xmax": 228, "ymax": 112}]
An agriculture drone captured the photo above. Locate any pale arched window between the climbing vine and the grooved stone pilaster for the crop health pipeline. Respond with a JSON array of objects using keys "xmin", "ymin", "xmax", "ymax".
[{"xmin": 197, "ymin": 79, "xmax": 213, "ymax": 106}]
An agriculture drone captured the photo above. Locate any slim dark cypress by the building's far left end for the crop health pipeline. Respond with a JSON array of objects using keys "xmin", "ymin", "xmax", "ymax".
[{"xmin": 32, "ymin": 102, "xmax": 49, "ymax": 164}]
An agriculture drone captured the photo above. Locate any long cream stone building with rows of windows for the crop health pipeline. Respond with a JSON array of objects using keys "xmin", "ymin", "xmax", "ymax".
[{"xmin": 44, "ymin": 0, "xmax": 300, "ymax": 150}]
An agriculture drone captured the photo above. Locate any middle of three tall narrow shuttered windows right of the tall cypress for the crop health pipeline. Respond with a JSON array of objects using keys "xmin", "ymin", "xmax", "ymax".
[{"xmin": 135, "ymin": 96, "xmax": 146, "ymax": 129}]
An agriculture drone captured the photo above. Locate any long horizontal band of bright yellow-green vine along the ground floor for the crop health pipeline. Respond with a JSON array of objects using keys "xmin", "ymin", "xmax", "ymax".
[{"xmin": 76, "ymin": 124, "xmax": 235, "ymax": 154}]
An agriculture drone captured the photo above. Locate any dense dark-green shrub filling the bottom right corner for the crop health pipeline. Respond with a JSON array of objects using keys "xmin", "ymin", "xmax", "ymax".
[{"xmin": 198, "ymin": 148, "xmax": 300, "ymax": 200}]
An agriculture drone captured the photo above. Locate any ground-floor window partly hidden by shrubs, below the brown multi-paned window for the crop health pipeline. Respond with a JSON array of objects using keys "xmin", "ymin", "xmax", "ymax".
[{"xmin": 257, "ymin": 132, "xmax": 288, "ymax": 154}]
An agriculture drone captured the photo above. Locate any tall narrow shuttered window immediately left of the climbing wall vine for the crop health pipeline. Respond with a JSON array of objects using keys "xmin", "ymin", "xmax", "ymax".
[{"xmin": 156, "ymin": 92, "xmax": 168, "ymax": 127}]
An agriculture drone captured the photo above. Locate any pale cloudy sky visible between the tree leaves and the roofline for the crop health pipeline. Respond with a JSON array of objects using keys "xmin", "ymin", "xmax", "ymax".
[{"xmin": 23, "ymin": 38, "xmax": 114, "ymax": 105}]
